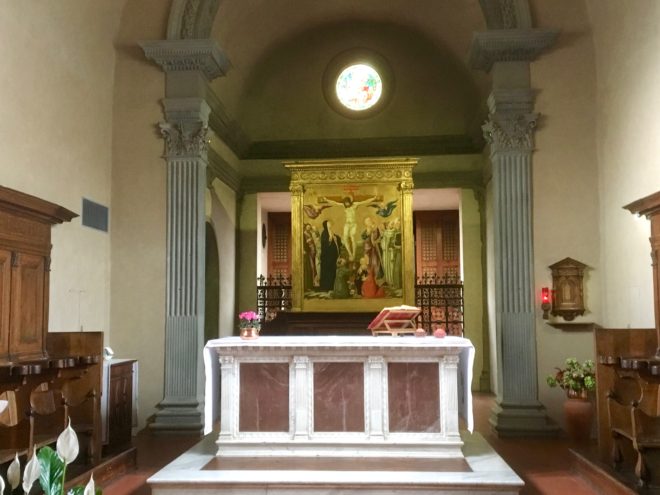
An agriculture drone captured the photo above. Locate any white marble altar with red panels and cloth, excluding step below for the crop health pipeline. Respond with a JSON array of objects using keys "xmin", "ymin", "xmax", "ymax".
[{"xmin": 205, "ymin": 336, "xmax": 474, "ymax": 459}]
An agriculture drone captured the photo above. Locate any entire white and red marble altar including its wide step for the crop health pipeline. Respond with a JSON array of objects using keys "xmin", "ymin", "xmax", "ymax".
[{"xmin": 149, "ymin": 336, "xmax": 523, "ymax": 495}]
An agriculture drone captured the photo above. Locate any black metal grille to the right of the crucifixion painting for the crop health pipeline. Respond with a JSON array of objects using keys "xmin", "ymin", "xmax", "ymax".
[{"xmin": 415, "ymin": 274, "xmax": 463, "ymax": 337}]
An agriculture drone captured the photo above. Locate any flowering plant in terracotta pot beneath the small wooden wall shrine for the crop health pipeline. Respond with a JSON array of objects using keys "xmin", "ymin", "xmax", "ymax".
[{"xmin": 546, "ymin": 358, "xmax": 596, "ymax": 443}]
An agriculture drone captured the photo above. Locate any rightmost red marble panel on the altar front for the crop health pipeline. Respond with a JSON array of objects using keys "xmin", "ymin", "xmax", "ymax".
[{"xmin": 387, "ymin": 363, "xmax": 440, "ymax": 432}]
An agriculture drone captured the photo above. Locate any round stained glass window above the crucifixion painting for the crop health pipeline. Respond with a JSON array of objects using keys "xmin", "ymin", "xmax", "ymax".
[{"xmin": 336, "ymin": 64, "xmax": 383, "ymax": 112}]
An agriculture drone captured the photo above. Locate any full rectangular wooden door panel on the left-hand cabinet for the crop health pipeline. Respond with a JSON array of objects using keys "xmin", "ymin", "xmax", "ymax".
[{"xmin": 9, "ymin": 253, "xmax": 47, "ymax": 360}]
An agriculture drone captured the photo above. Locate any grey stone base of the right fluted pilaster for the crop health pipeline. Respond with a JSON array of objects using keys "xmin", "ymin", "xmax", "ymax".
[{"xmin": 489, "ymin": 402, "xmax": 559, "ymax": 438}]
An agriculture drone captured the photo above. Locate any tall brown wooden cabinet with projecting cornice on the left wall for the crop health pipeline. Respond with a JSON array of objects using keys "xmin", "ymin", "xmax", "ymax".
[{"xmin": 0, "ymin": 186, "xmax": 78, "ymax": 365}]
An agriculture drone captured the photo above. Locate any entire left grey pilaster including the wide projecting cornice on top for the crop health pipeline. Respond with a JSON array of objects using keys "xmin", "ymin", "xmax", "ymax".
[{"xmin": 141, "ymin": 39, "xmax": 228, "ymax": 431}]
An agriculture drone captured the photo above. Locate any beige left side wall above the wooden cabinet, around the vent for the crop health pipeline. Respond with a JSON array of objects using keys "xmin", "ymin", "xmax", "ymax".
[{"xmin": 0, "ymin": 0, "xmax": 123, "ymax": 340}]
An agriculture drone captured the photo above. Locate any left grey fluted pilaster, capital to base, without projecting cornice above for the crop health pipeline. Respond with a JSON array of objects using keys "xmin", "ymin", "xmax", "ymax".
[{"xmin": 151, "ymin": 98, "xmax": 210, "ymax": 430}]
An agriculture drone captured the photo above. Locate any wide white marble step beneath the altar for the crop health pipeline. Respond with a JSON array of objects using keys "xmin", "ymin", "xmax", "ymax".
[{"xmin": 148, "ymin": 433, "xmax": 523, "ymax": 495}]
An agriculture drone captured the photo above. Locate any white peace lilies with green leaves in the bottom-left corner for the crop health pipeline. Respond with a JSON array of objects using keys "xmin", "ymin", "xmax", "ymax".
[{"xmin": 0, "ymin": 419, "xmax": 102, "ymax": 495}]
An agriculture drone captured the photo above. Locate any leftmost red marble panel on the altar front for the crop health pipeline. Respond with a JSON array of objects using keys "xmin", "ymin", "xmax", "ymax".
[{"xmin": 238, "ymin": 363, "xmax": 289, "ymax": 432}]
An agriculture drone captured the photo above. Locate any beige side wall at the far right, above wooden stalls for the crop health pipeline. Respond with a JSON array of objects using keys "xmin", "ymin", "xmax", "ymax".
[{"xmin": 586, "ymin": 0, "xmax": 660, "ymax": 328}]
